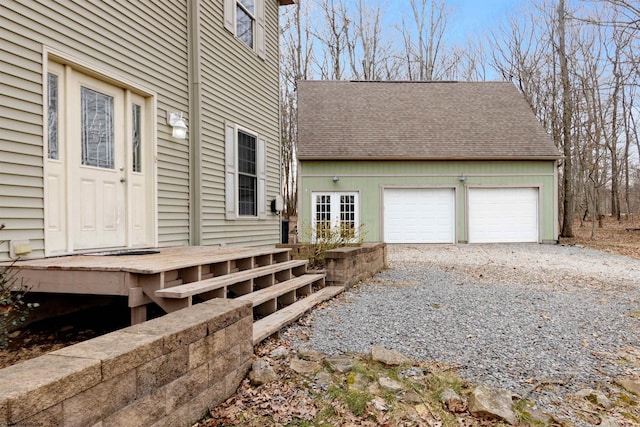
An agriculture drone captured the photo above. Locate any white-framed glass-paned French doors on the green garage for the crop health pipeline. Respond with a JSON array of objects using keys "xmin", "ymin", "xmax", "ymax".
[{"xmin": 311, "ymin": 192, "xmax": 360, "ymax": 241}]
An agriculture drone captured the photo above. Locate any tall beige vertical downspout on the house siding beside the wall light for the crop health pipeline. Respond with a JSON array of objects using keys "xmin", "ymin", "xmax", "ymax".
[{"xmin": 187, "ymin": 0, "xmax": 202, "ymax": 246}]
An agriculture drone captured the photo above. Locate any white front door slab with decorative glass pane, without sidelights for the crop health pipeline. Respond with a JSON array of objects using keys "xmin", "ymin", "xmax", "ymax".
[{"xmin": 69, "ymin": 75, "xmax": 127, "ymax": 249}]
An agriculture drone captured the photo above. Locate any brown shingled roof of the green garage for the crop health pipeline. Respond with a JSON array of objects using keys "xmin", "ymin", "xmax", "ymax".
[{"xmin": 298, "ymin": 81, "xmax": 561, "ymax": 160}]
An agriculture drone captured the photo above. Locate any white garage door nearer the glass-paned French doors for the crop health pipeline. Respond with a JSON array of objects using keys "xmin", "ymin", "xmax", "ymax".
[{"xmin": 384, "ymin": 188, "xmax": 456, "ymax": 243}]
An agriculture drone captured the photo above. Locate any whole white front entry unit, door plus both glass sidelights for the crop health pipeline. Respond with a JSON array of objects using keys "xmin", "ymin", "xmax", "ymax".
[{"xmin": 45, "ymin": 62, "xmax": 156, "ymax": 255}]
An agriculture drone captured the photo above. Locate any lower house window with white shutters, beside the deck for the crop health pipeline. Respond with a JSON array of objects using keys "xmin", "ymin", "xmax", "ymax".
[{"xmin": 225, "ymin": 123, "xmax": 267, "ymax": 219}]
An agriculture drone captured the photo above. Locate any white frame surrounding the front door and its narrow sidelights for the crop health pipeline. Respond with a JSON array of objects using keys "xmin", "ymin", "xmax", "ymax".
[{"xmin": 42, "ymin": 46, "xmax": 158, "ymax": 256}]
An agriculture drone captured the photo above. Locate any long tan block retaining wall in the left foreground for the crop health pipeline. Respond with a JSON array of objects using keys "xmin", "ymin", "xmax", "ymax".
[{"xmin": 0, "ymin": 299, "xmax": 253, "ymax": 427}]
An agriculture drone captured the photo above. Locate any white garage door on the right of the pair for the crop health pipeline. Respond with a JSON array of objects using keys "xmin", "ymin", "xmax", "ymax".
[{"xmin": 469, "ymin": 188, "xmax": 538, "ymax": 243}]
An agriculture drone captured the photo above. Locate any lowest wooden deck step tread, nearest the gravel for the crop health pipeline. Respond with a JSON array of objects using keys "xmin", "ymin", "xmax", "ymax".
[{"xmin": 253, "ymin": 286, "xmax": 344, "ymax": 345}]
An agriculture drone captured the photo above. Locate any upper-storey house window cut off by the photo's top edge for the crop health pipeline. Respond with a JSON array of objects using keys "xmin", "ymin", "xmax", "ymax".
[{"xmin": 224, "ymin": 0, "xmax": 265, "ymax": 59}]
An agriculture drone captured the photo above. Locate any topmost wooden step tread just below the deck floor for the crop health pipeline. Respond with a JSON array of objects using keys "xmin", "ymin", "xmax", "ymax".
[{"xmin": 154, "ymin": 260, "xmax": 308, "ymax": 298}]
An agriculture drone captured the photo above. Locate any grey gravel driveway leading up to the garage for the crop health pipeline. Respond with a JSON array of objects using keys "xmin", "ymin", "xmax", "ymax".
[{"xmin": 284, "ymin": 244, "xmax": 640, "ymax": 416}]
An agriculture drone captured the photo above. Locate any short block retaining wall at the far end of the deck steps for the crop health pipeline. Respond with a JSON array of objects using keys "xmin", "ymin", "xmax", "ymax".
[{"xmin": 325, "ymin": 243, "xmax": 387, "ymax": 288}]
